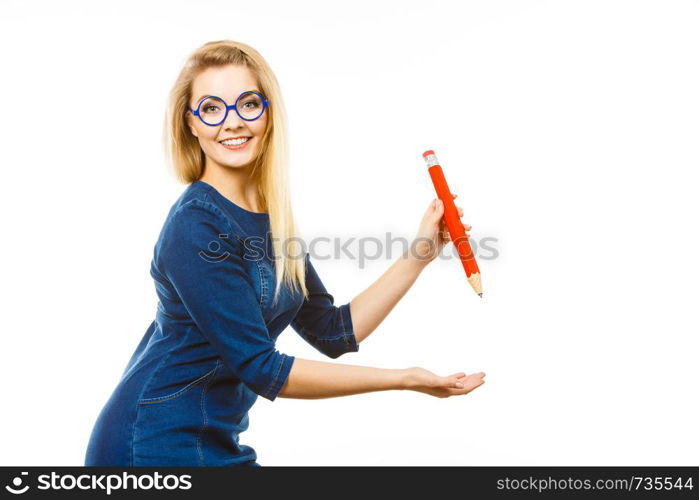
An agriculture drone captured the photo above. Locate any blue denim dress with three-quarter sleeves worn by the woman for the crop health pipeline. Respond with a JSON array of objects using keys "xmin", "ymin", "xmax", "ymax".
[{"xmin": 85, "ymin": 181, "xmax": 359, "ymax": 467}]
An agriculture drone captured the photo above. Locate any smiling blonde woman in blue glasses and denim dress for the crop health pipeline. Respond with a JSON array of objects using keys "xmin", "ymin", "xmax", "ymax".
[{"xmin": 85, "ymin": 41, "xmax": 484, "ymax": 466}]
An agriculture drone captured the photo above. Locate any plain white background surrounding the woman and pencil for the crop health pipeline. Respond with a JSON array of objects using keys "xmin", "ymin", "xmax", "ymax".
[{"xmin": 0, "ymin": 0, "xmax": 699, "ymax": 465}]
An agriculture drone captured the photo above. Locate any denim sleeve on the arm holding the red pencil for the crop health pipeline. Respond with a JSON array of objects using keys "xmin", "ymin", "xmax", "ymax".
[{"xmin": 291, "ymin": 253, "xmax": 359, "ymax": 358}]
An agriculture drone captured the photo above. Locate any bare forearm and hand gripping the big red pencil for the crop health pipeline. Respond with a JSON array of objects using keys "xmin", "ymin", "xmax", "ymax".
[{"xmin": 350, "ymin": 194, "xmax": 471, "ymax": 343}]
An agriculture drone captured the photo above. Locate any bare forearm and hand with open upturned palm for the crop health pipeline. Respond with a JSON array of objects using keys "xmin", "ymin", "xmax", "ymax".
[{"xmin": 278, "ymin": 358, "xmax": 485, "ymax": 399}]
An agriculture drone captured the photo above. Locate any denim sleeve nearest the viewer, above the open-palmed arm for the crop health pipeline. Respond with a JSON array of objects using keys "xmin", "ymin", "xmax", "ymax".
[{"xmin": 156, "ymin": 199, "xmax": 294, "ymax": 401}]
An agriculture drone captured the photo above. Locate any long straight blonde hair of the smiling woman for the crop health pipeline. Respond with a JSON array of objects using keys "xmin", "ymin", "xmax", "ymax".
[{"xmin": 164, "ymin": 40, "xmax": 308, "ymax": 300}]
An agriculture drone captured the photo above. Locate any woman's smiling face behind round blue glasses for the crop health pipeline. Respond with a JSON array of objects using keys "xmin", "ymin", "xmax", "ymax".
[{"xmin": 187, "ymin": 64, "xmax": 268, "ymax": 172}]
